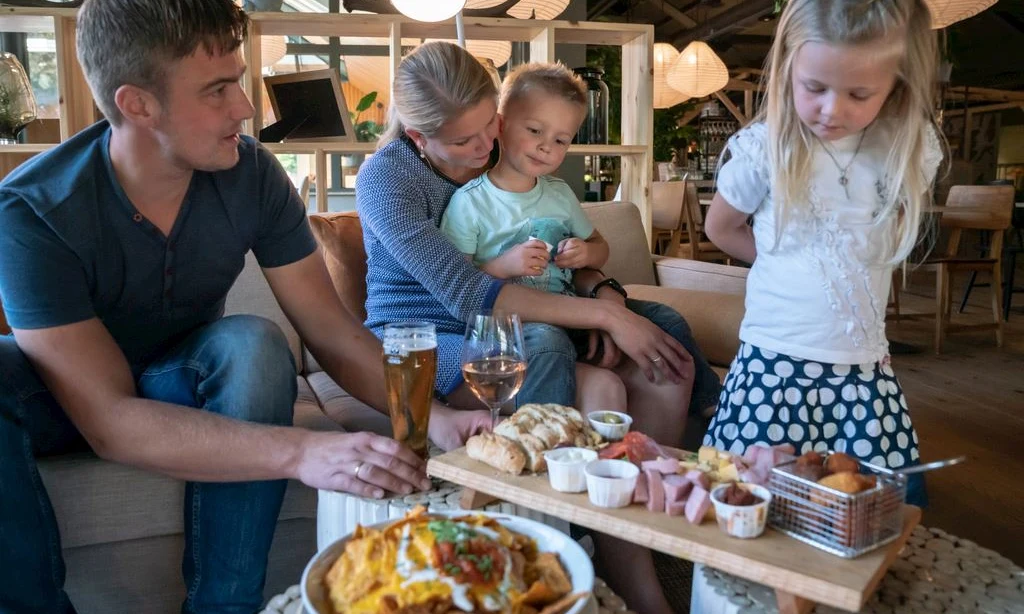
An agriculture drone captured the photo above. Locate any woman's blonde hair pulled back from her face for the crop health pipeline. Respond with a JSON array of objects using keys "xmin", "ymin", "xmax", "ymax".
[{"xmin": 377, "ymin": 41, "xmax": 498, "ymax": 147}]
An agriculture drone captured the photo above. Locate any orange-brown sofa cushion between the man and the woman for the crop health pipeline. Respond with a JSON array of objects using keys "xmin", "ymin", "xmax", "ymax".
[{"xmin": 309, "ymin": 212, "xmax": 367, "ymax": 322}]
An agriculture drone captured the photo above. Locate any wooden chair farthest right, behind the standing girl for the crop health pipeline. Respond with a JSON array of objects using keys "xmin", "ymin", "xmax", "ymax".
[{"xmin": 920, "ymin": 185, "xmax": 1014, "ymax": 354}]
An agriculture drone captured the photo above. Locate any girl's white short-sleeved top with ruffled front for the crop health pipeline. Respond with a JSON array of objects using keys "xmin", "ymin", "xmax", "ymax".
[{"xmin": 718, "ymin": 122, "xmax": 942, "ymax": 364}]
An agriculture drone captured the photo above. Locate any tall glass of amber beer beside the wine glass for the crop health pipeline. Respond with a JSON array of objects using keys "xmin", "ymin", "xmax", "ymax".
[{"xmin": 382, "ymin": 321, "xmax": 437, "ymax": 458}]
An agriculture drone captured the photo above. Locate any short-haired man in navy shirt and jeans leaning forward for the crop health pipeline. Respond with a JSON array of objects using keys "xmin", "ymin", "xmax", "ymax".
[{"xmin": 0, "ymin": 0, "xmax": 489, "ymax": 613}]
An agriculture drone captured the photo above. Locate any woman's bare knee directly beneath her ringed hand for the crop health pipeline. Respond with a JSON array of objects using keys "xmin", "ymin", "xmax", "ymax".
[{"xmin": 615, "ymin": 359, "xmax": 693, "ymax": 447}]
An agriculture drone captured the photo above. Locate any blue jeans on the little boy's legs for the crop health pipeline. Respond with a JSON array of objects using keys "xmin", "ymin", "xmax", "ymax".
[{"xmin": 516, "ymin": 299, "xmax": 721, "ymax": 411}]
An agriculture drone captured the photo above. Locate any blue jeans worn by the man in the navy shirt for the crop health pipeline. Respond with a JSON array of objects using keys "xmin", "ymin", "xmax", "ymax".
[{"xmin": 0, "ymin": 315, "xmax": 296, "ymax": 614}]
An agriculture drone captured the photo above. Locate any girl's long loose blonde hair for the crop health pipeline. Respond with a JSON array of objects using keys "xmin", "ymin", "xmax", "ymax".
[{"xmin": 758, "ymin": 0, "xmax": 939, "ymax": 264}]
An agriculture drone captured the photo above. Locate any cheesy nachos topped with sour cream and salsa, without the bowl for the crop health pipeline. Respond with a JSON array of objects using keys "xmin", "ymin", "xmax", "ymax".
[{"xmin": 327, "ymin": 509, "xmax": 571, "ymax": 614}]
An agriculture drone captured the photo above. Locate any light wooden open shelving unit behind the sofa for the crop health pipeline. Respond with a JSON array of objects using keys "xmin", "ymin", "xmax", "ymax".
[{"xmin": 0, "ymin": 7, "xmax": 654, "ymax": 233}]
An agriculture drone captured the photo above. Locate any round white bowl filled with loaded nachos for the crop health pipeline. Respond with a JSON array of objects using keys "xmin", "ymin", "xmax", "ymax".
[{"xmin": 301, "ymin": 508, "xmax": 594, "ymax": 614}]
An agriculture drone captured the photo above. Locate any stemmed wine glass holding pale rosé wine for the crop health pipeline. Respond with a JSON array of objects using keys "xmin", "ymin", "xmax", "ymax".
[{"xmin": 462, "ymin": 311, "xmax": 526, "ymax": 428}]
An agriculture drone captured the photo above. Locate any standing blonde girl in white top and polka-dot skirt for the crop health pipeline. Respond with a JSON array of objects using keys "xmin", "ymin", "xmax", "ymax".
[{"xmin": 705, "ymin": 0, "xmax": 942, "ymax": 505}]
